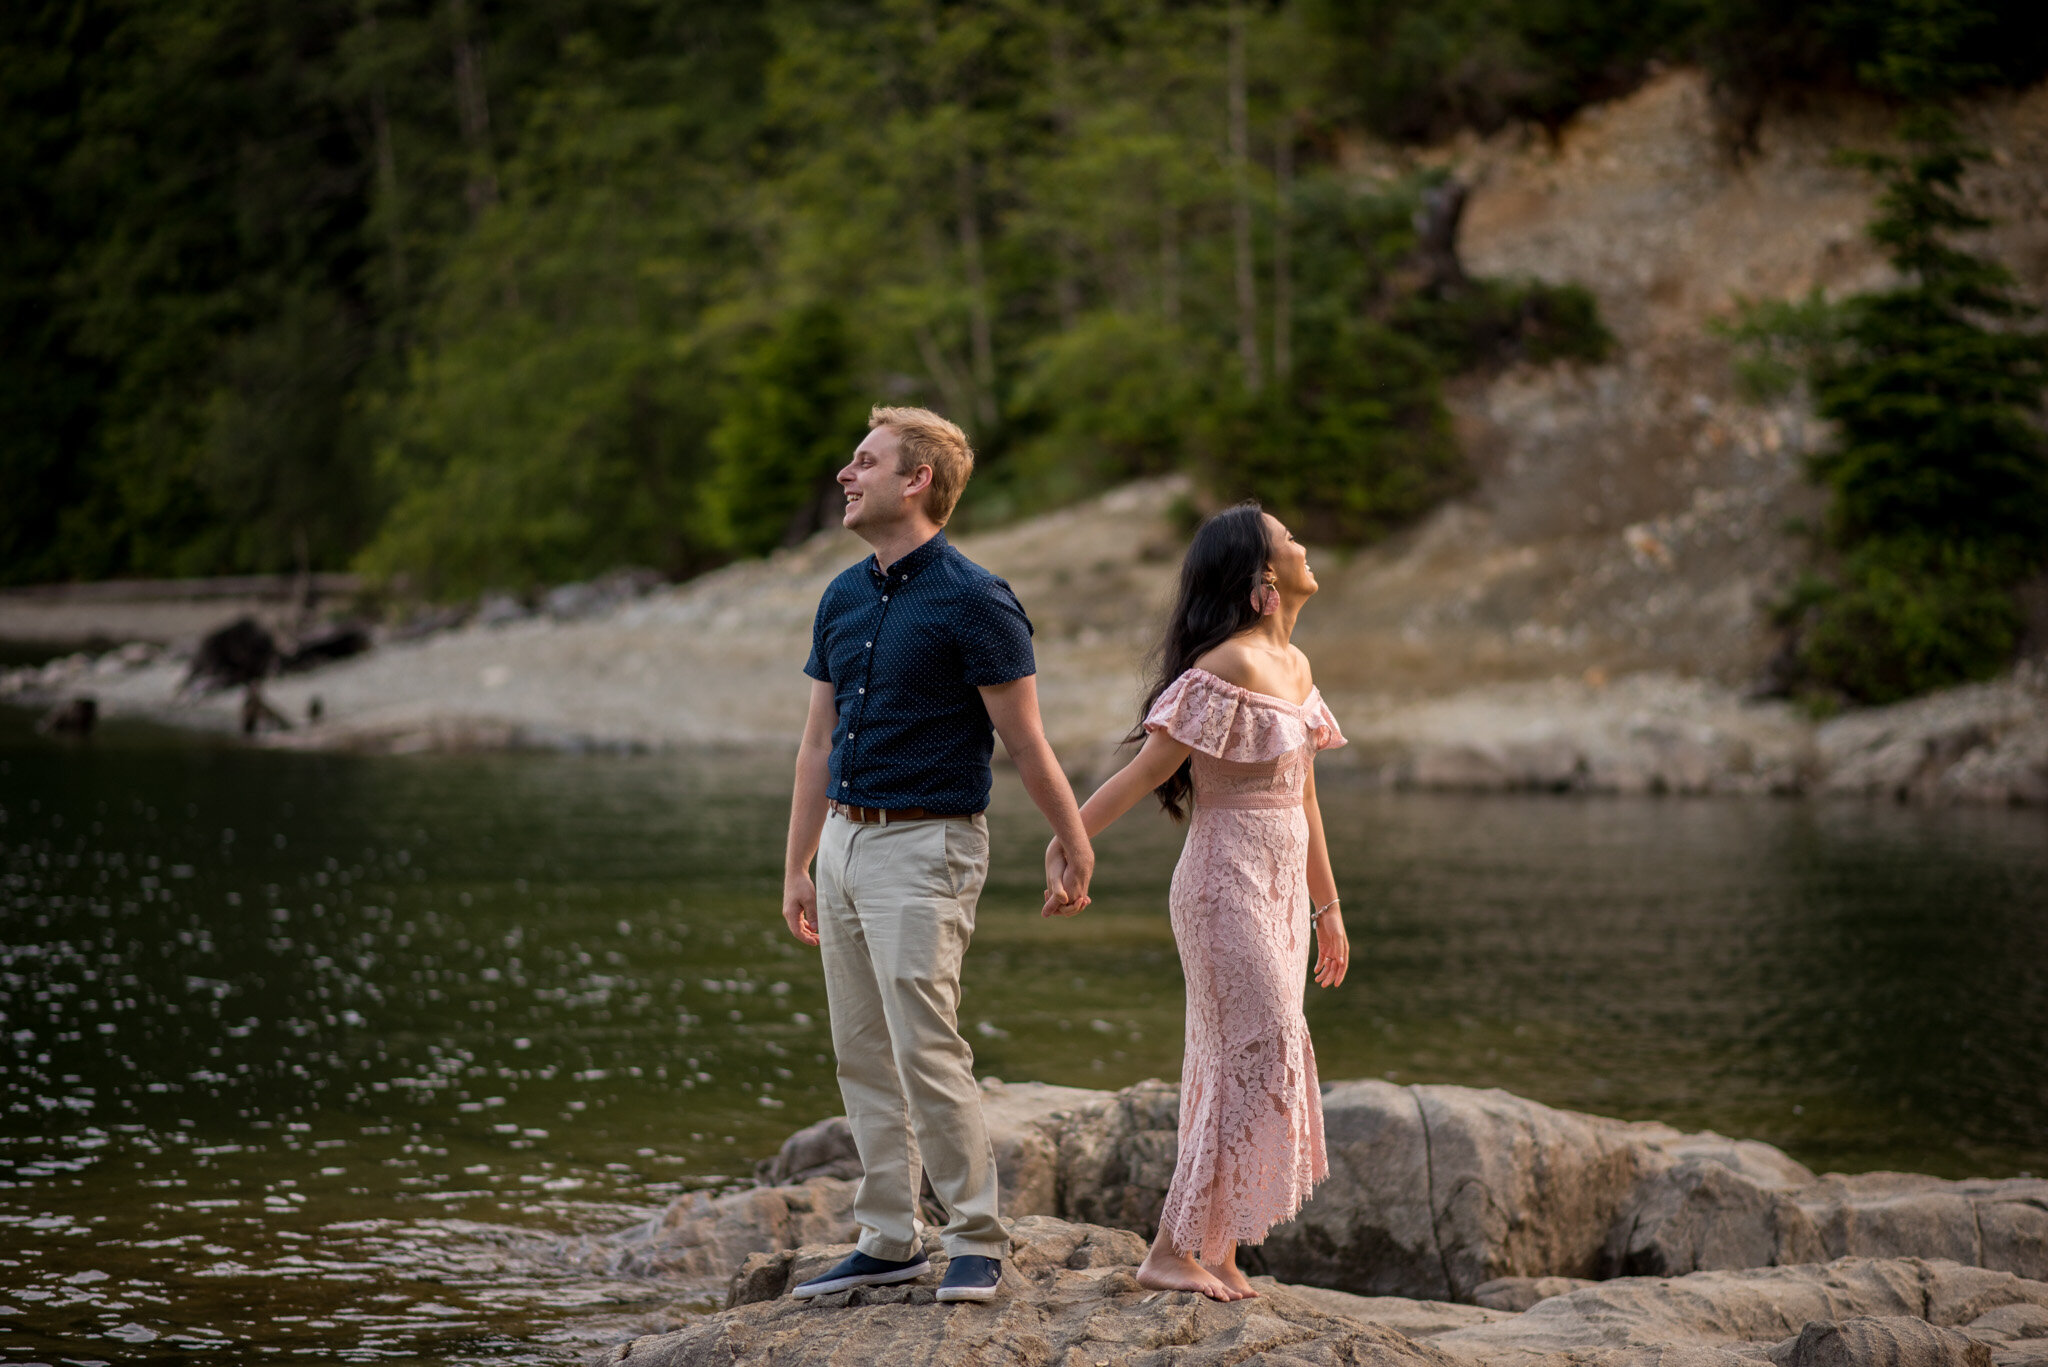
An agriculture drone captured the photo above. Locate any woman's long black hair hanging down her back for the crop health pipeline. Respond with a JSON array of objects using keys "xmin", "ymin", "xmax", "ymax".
[{"xmin": 1124, "ymin": 498, "xmax": 1272, "ymax": 822}]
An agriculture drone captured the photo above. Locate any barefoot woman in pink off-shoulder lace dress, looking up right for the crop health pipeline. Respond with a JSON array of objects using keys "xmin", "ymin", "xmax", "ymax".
[{"xmin": 1047, "ymin": 504, "xmax": 1350, "ymax": 1301}]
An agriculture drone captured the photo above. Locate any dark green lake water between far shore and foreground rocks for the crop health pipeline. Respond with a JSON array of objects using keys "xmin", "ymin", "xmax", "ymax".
[{"xmin": 0, "ymin": 711, "xmax": 2048, "ymax": 1363}]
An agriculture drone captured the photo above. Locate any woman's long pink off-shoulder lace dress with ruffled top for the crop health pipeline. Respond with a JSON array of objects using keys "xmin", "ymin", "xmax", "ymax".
[{"xmin": 1145, "ymin": 670, "xmax": 1343, "ymax": 1260}]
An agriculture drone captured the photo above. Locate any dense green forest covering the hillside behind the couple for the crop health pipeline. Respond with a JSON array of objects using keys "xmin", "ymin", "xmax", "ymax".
[{"xmin": 0, "ymin": 0, "xmax": 2048, "ymax": 647}]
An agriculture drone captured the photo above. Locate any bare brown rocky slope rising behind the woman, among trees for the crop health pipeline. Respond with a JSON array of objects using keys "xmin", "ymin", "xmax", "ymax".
[{"xmin": 1303, "ymin": 70, "xmax": 2048, "ymax": 693}]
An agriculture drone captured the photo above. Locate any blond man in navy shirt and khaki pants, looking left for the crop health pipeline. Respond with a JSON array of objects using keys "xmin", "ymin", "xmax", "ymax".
[{"xmin": 782, "ymin": 408, "xmax": 1096, "ymax": 1301}]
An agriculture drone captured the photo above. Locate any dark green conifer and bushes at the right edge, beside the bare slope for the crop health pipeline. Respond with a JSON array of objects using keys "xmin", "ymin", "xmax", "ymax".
[{"xmin": 1743, "ymin": 0, "xmax": 2048, "ymax": 703}]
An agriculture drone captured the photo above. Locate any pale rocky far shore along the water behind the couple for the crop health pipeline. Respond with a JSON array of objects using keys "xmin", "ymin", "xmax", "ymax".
[{"xmin": 0, "ymin": 573, "xmax": 2048, "ymax": 805}]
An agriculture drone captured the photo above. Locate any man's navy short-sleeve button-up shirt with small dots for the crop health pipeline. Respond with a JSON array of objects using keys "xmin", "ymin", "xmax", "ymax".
[{"xmin": 803, "ymin": 533, "xmax": 1038, "ymax": 816}]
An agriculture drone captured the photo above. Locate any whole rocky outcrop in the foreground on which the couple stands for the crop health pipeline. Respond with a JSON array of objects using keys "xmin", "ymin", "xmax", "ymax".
[{"xmin": 567, "ymin": 1080, "xmax": 2048, "ymax": 1367}]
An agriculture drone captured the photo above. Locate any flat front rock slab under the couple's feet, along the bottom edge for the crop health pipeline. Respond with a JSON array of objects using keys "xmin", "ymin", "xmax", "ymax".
[{"xmin": 594, "ymin": 1215, "xmax": 2048, "ymax": 1367}]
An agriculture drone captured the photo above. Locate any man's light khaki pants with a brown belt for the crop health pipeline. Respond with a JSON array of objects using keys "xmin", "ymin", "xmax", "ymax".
[{"xmin": 817, "ymin": 816, "xmax": 1010, "ymax": 1260}]
